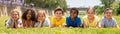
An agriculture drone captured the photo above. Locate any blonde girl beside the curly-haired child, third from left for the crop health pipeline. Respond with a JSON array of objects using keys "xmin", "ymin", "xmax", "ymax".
[{"xmin": 34, "ymin": 11, "xmax": 50, "ymax": 28}]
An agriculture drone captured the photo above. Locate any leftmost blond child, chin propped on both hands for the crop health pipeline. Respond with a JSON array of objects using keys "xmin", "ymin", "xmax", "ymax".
[{"xmin": 6, "ymin": 9, "xmax": 22, "ymax": 28}]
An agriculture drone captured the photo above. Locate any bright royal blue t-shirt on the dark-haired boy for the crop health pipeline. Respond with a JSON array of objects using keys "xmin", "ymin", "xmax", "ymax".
[{"xmin": 66, "ymin": 16, "xmax": 82, "ymax": 27}]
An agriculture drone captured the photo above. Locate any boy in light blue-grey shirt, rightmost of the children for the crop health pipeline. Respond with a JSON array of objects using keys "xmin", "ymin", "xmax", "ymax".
[{"xmin": 100, "ymin": 8, "xmax": 118, "ymax": 28}]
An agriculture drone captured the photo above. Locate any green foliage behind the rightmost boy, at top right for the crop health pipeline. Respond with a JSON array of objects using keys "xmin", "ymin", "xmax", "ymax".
[{"xmin": 94, "ymin": 0, "xmax": 120, "ymax": 15}]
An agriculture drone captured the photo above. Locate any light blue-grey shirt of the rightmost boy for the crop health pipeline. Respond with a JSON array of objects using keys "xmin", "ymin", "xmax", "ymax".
[{"xmin": 100, "ymin": 17, "xmax": 117, "ymax": 28}]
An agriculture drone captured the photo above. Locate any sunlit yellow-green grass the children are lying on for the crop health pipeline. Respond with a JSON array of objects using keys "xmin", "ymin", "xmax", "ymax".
[{"xmin": 0, "ymin": 16, "xmax": 120, "ymax": 34}]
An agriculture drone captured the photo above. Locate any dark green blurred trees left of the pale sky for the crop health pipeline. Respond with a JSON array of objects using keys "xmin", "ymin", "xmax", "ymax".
[{"xmin": 25, "ymin": 0, "xmax": 67, "ymax": 9}]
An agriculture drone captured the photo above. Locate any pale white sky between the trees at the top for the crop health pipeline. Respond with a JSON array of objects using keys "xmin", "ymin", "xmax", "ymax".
[{"xmin": 66, "ymin": 0, "xmax": 101, "ymax": 8}]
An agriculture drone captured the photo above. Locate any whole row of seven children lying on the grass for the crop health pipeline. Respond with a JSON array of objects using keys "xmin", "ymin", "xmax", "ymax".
[{"xmin": 6, "ymin": 7, "xmax": 118, "ymax": 28}]
